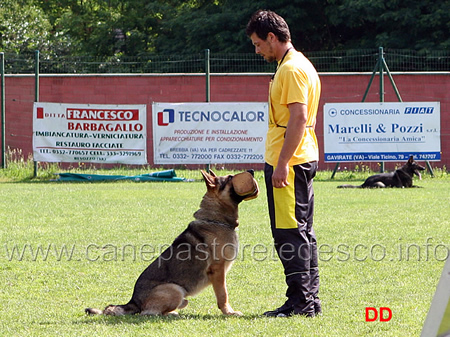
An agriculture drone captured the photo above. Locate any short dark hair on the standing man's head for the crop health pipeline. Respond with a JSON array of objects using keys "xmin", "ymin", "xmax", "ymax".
[{"xmin": 245, "ymin": 10, "xmax": 291, "ymax": 42}]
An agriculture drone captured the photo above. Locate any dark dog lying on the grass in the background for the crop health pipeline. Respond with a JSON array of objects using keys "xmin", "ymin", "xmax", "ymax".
[{"xmin": 338, "ymin": 156, "xmax": 425, "ymax": 188}]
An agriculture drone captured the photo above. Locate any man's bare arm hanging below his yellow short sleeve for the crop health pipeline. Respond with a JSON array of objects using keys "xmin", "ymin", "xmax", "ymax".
[{"xmin": 272, "ymin": 103, "xmax": 308, "ymax": 188}]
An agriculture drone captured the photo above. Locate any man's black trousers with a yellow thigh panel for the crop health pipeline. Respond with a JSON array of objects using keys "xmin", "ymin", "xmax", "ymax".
[{"xmin": 264, "ymin": 162, "xmax": 321, "ymax": 314}]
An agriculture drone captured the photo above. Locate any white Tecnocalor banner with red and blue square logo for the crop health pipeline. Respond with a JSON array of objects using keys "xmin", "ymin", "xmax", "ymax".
[{"xmin": 152, "ymin": 102, "xmax": 268, "ymax": 164}]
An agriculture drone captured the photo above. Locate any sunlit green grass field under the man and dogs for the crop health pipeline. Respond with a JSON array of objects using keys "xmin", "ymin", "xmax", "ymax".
[{"xmin": 0, "ymin": 167, "xmax": 450, "ymax": 336}]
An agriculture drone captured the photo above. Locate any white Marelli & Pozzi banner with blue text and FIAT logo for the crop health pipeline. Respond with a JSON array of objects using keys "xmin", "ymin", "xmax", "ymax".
[{"xmin": 323, "ymin": 102, "xmax": 441, "ymax": 162}]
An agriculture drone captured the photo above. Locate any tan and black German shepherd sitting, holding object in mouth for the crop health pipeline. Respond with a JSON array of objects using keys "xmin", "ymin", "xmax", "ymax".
[{"xmin": 85, "ymin": 170, "xmax": 259, "ymax": 316}]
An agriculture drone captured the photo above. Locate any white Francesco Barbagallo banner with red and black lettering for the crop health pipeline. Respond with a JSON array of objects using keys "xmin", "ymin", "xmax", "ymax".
[{"xmin": 33, "ymin": 102, "xmax": 147, "ymax": 165}]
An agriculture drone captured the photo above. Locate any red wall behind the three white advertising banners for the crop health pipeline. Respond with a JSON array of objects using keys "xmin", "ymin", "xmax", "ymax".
[{"xmin": 1, "ymin": 73, "xmax": 450, "ymax": 170}]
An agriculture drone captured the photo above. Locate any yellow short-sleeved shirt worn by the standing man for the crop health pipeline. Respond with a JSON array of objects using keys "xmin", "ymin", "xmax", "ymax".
[{"xmin": 265, "ymin": 50, "xmax": 321, "ymax": 166}]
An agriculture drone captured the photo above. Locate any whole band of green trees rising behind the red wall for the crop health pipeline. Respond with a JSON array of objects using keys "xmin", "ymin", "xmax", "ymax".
[{"xmin": 15, "ymin": 0, "xmax": 450, "ymax": 57}]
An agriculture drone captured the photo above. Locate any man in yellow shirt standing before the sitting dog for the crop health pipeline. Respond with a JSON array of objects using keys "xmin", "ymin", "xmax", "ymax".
[{"xmin": 246, "ymin": 10, "xmax": 322, "ymax": 317}]
